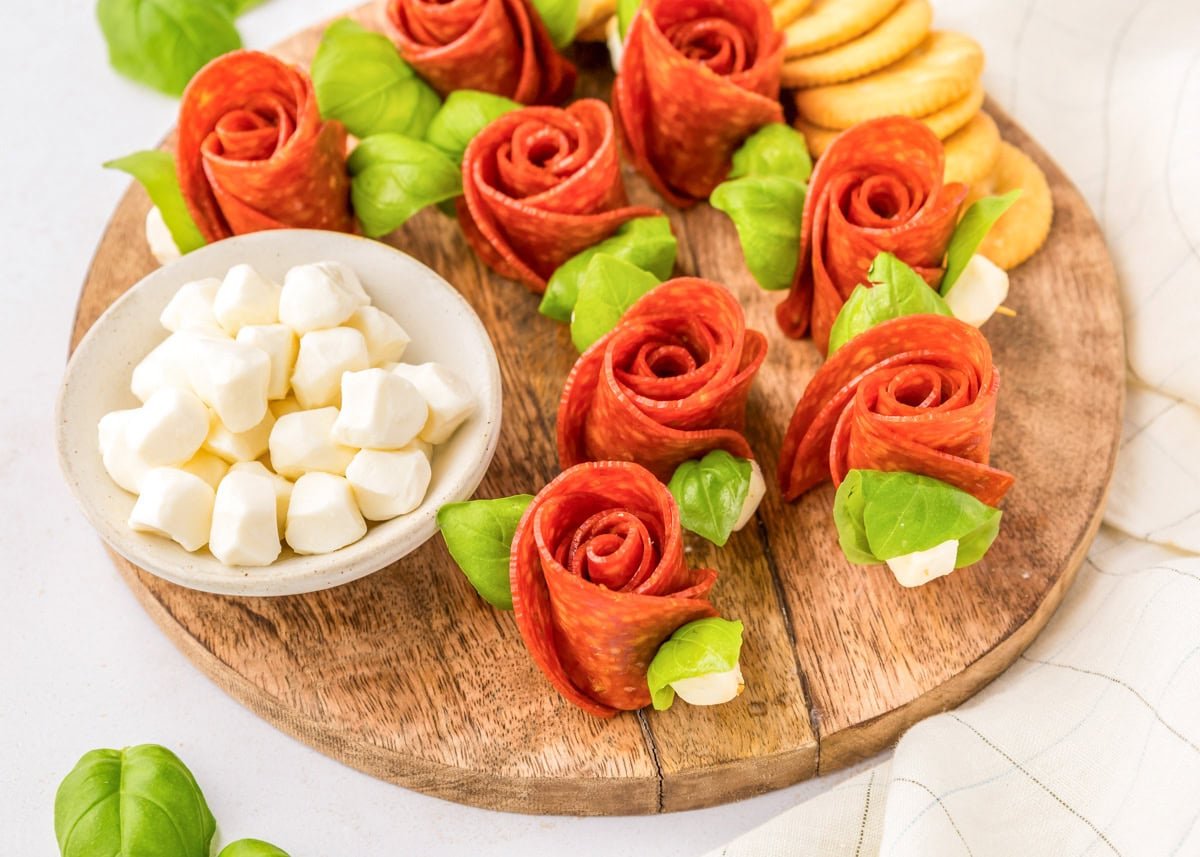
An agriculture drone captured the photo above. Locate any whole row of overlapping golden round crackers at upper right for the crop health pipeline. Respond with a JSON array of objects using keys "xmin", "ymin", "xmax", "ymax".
[{"xmin": 772, "ymin": 0, "xmax": 1054, "ymax": 268}]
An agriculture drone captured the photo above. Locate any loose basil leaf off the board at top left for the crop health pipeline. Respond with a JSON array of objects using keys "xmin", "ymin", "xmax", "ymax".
[{"xmin": 96, "ymin": 0, "xmax": 241, "ymax": 95}]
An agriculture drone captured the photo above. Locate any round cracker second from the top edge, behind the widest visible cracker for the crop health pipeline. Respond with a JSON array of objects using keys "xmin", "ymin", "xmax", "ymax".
[{"xmin": 782, "ymin": 0, "xmax": 934, "ymax": 89}]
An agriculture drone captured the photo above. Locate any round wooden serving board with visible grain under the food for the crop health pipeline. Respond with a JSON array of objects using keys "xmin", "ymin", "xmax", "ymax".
[{"xmin": 74, "ymin": 1, "xmax": 1124, "ymax": 815}]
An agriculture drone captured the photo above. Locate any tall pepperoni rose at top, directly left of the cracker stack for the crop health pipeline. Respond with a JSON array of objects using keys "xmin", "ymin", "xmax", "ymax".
[{"xmin": 612, "ymin": 0, "xmax": 784, "ymax": 205}]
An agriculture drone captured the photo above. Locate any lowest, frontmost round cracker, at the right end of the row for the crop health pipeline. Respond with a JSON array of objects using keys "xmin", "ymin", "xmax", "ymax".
[{"xmin": 979, "ymin": 140, "xmax": 1054, "ymax": 270}]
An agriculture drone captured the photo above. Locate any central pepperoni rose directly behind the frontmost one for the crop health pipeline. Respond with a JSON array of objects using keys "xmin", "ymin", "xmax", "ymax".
[{"xmin": 558, "ymin": 277, "xmax": 767, "ymax": 481}]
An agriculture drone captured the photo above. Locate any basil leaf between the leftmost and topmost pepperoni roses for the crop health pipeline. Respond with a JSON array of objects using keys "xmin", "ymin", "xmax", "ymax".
[{"xmin": 312, "ymin": 18, "xmax": 442, "ymax": 138}]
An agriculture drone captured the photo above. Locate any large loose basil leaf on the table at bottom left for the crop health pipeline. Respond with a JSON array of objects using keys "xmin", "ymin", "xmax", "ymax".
[{"xmin": 54, "ymin": 744, "xmax": 216, "ymax": 857}]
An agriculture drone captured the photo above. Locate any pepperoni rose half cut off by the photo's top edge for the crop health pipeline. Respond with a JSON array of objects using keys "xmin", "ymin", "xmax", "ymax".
[{"xmin": 385, "ymin": 0, "xmax": 575, "ymax": 104}]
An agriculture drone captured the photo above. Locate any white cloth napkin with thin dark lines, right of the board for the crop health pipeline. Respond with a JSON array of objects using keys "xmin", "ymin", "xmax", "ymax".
[{"xmin": 714, "ymin": 0, "xmax": 1200, "ymax": 857}]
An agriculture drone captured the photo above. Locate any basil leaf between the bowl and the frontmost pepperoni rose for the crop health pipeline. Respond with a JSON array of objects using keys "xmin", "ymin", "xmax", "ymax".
[{"xmin": 438, "ymin": 495, "xmax": 533, "ymax": 610}]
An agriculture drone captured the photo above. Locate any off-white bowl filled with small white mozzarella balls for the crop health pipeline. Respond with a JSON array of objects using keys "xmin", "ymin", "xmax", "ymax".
[{"xmin": 56, "ymin": 229, "xmax": 502, "ymax": 595}]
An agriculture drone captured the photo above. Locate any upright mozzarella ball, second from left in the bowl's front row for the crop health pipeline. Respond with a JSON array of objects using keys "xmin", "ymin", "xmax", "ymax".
[{"xmin": 209, "ymin": 471, "xmax": 280, "ymax": 565}]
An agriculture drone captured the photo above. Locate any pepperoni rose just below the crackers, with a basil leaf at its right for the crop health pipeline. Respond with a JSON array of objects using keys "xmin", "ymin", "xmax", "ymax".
[{"xmin": 775, "ymin": 116, "xmax": 970, "ymax": 352}]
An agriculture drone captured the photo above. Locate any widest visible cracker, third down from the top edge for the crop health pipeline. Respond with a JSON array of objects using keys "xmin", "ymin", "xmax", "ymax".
[{"xmin": 796, "ymin": 30, "xmax": 983, "ymax": 128}]
